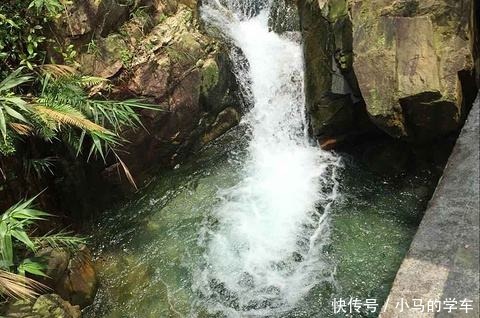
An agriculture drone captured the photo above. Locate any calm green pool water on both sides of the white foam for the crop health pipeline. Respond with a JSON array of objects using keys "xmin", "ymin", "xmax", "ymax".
[{"xmin": 84, "ymin": 129, "xmax": 435, "ymax": 318}]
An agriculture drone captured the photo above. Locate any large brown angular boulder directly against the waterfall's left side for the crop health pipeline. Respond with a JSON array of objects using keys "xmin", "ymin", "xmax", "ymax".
[{"xmin": 95, "ymin": 1, "xmax": 240, "ymax": 179}]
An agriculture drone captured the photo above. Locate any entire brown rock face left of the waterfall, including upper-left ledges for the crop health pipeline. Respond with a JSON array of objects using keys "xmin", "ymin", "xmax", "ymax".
[{"xmin": 54, "ymin": 0, "xmax": 242, "ymax": 188}]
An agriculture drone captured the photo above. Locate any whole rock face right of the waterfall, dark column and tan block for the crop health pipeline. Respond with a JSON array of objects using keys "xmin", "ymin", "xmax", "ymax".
[{"xmin": 299, "ymin": 0, "xmax": 477, "ymax": 142}]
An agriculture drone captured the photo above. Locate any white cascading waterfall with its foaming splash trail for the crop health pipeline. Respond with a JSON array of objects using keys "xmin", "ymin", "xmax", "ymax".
[{"xmin": 194, "ymin": 0, "xmax": 339, "ymax": 317}]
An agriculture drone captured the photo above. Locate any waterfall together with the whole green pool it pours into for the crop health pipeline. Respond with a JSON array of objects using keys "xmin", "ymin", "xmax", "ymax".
[{"xmin": 86, "ymin": 0, "xmax": 434, "ymax": 317}]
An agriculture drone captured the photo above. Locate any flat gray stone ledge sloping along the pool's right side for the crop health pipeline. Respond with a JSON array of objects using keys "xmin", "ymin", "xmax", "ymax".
[{"xmin": 380, "ymin": 94, "xmax": 480, "ymax": 318}]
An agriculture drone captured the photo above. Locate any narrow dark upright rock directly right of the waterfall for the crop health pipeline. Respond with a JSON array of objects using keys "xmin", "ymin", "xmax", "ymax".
[{"xmin": 299, "ymin": 0, "xmax": 360, "ymax": 138}]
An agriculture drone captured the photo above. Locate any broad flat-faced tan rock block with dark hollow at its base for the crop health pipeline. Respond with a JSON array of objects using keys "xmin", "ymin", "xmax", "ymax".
[{"xmin": 350, "ymin": 0, "xmax": 473, "ymax": 141}]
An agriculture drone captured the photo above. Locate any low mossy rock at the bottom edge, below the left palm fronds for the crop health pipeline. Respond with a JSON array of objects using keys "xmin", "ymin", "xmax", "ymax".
[{"xmin": 5, "ymin": 294, "xmax": 81, "ymax": 318}]
